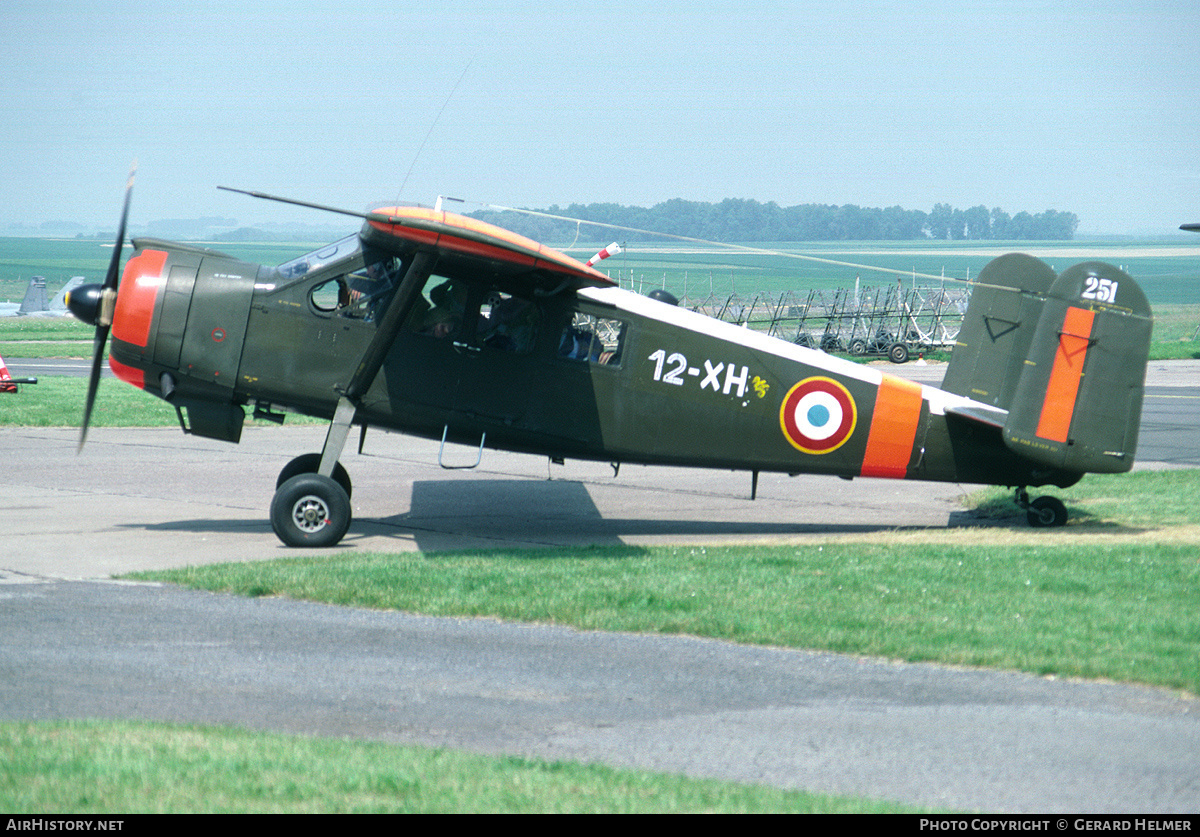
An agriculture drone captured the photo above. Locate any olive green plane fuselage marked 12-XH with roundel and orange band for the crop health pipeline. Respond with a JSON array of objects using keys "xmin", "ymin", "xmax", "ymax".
[{"xmin": 113, "ymin": 236, "xmax": 1079, "ymax": 486}]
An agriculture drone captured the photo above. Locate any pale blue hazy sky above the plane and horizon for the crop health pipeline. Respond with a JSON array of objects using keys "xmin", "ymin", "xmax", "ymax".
[{"xmin": 0, "ymin": 0, "xmax": 1200, "ymax": 235}]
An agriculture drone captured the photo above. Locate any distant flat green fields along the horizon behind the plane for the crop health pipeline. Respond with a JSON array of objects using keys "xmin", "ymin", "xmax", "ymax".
[{"xmin": 7, "ymin": 232, "xmax": 1200, "ymax": 300}]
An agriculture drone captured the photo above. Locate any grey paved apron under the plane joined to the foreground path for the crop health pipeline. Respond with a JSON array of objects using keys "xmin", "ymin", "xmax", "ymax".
[{"xmin": 0, "ymin": 363, "xmax": 1200, "ymax": 813}]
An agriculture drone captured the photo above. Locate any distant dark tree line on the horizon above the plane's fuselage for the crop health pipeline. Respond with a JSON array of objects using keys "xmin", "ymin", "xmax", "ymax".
[{"xmin": 472, "ymin": 198, "xmax": 1079, "ymax": 241}]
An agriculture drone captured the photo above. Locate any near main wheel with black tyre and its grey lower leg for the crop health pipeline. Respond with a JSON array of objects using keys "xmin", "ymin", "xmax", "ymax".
[{"xmin": 271, "ymin": 397, "xmax": 355, "ymax": 547}]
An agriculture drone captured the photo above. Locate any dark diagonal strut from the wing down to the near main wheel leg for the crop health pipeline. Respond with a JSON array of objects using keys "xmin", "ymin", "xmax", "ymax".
[{"xmin": 317, "ymin": 253, "xmax": 437, "ymax": 477}]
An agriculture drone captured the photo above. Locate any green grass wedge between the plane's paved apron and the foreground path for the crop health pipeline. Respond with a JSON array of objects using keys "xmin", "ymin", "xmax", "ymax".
[{"xmin": 131, "ymin": 471, "xmax": 1200, "ymax": 694}]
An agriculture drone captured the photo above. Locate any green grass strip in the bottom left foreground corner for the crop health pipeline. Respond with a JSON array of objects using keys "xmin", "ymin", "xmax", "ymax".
[{"xmin": 0, "ymin": 722, "xmax": 911, "ymax": 814}]
